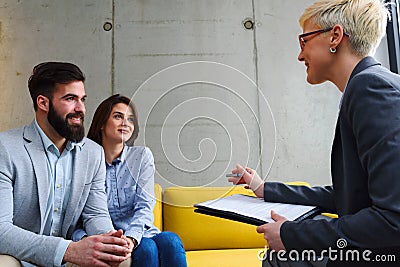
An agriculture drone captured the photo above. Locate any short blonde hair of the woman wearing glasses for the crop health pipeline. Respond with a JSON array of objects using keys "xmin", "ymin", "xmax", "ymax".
[{"xmin": 299, "ymin": 0, "xmax": 389, "ymax": 57}]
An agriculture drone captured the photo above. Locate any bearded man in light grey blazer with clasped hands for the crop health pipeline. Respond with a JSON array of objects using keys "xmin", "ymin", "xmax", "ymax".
[{"xmin": 0, "ymin": 62, "xmax": 131, "ymax": 266}]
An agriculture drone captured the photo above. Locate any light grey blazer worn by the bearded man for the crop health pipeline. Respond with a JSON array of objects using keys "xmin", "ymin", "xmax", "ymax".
[{"xmin": 0, "ymin": 122, "xmax": 113, "ymax": 266}]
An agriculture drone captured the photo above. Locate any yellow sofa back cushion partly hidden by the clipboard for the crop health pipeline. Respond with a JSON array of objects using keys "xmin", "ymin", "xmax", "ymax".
[{"xmin": 163, "ymin": 186, "xmax": 266, "ymax": 251}]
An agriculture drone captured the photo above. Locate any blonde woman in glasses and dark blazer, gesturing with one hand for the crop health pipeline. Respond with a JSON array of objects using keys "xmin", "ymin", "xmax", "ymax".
[{"xmin": 229, "ymin": 0, "xmax": 400, "ymax": 266}]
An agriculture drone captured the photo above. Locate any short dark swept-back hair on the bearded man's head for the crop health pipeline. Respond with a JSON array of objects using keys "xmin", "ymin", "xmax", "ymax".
[{"xmin": 28, "ymin": 62, "xmax": 85, "ymax": 111}]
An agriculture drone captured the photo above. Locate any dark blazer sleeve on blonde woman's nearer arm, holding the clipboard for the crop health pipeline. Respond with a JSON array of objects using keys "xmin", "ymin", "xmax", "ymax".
[{"xmin": 281, "ymin": 72, "xmax": 400, "ymax": 251}]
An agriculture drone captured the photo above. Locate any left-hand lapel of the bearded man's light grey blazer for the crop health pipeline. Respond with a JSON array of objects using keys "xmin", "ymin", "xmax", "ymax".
[{"xmin": 23, "ymin": 122, "xmax": 49, "ymax": 232}]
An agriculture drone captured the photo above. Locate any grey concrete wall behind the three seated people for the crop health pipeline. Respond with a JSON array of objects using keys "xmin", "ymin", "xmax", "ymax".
[{"xmin": 0, "ymin": 0, "xmax": 387, "ymax": 187}]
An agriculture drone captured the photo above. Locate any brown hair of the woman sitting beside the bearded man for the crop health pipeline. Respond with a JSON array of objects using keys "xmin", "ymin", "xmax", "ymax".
[{"xmin": 87, "ymin": 94, "xmax": 139, "ymax": 146}]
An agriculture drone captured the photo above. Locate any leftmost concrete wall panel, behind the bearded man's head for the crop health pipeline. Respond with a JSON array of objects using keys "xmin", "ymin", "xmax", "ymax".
[{"xmin": 0, "ymin": 0, "xmax": 112, "ymax": 130}]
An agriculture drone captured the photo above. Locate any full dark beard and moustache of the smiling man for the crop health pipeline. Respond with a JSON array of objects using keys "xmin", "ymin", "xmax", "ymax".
[{"xmin": 47, "ymin": 101, "xmax": 85, "ymax": 143}]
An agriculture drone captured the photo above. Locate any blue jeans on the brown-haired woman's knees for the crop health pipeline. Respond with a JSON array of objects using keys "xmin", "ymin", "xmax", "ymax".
[{"xmin": 131, "ymin": 232, "xmax": 187, "ymax": 267}]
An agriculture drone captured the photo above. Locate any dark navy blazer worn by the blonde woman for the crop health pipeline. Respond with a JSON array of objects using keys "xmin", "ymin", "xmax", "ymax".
[{"xmin": 264, "ymin": 57, "xmax": 400, "ymax": 251}]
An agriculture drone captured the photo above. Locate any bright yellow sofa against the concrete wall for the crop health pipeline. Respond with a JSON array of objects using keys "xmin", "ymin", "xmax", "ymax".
[{"xmin": 154, "ymin": 185, "xmax": 267, "ymax": 267}]
